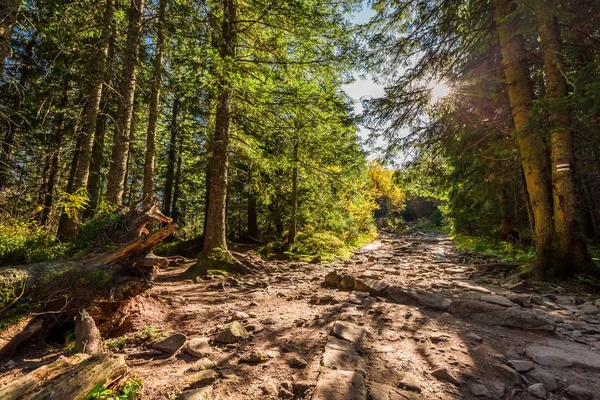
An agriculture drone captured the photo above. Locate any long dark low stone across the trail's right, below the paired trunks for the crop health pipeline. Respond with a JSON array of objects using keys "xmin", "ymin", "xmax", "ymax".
[{"xmin": 448, "ymin": 300, "xmax": 556, "ymax": 331}]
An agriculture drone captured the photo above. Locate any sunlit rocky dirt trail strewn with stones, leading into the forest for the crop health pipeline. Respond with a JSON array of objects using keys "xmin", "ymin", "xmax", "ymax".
[{"xmin": 0, "ymin": 232, "xmax": 600, "ymax": 400}]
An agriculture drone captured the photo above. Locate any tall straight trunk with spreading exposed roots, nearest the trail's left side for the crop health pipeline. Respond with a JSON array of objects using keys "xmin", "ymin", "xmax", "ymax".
[{"xmin": 204, "ymin": 0, "xmax": 236, "ymax": 257}]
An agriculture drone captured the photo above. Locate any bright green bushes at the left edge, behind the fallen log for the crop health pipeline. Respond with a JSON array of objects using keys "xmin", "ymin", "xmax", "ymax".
[{"xmin": 0, "ymin": 219, "xmax": 68, "ymax": 265}]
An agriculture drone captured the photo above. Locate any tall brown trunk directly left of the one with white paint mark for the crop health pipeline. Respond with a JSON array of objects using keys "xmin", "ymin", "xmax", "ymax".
[{"xmin": 494, "ymin": 0, "xmax": 554, "ymax": 277}]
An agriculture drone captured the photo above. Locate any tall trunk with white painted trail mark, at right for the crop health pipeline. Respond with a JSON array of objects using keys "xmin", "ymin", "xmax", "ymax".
[{"xmin": 536, "ymin": 0, "xmax": 591, "ymax": 278}]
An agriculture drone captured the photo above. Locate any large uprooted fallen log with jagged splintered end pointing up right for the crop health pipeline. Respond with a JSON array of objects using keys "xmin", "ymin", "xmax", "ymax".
[{"xmin": 0, "ymin": 224, "xmax": 177, "ymax": 355}]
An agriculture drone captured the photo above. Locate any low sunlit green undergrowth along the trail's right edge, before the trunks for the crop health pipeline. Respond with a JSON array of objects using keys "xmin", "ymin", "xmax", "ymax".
[{"xmin": 454, "ymin": 234, "xmax": 535, "ymax": 262}]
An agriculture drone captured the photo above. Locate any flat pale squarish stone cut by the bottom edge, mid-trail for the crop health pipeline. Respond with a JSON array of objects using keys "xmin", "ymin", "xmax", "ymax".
[{"xmin": 312, "ymin": 369, "xmax": 367, "ymax": 400}]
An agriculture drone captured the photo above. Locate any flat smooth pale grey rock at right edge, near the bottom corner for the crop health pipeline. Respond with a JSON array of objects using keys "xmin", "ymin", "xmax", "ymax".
[{"xmin": 525, "ymin": 341, "xmax": 600, "ymax": 371}]
